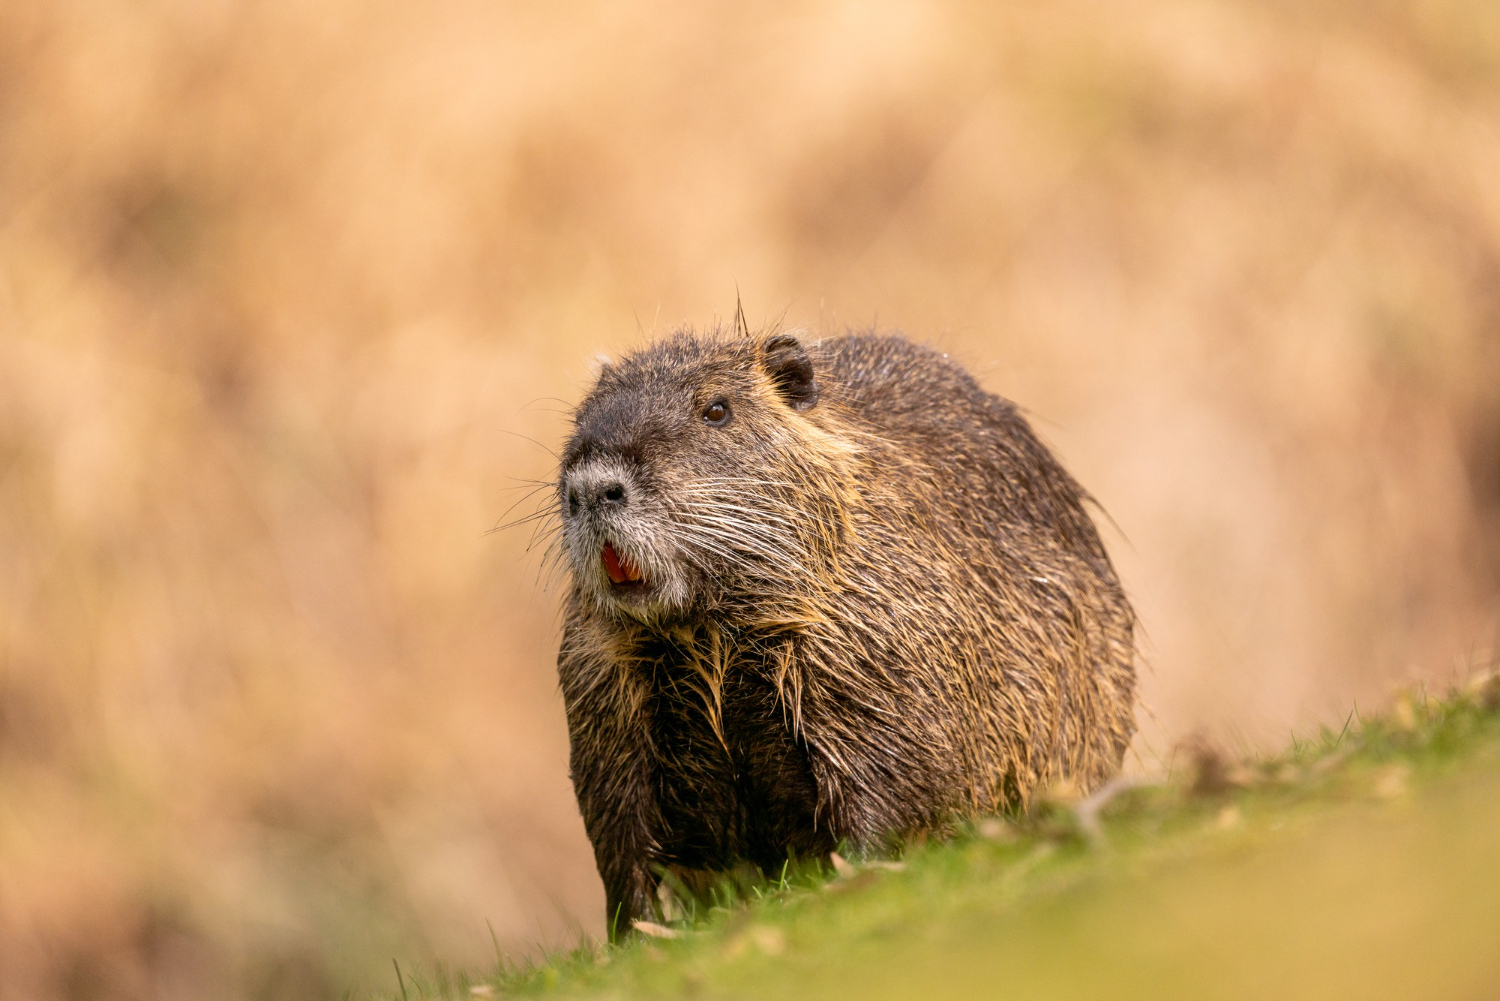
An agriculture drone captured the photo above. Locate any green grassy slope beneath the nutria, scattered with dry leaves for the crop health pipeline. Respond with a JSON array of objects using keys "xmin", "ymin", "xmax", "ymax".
[{"xmin": 404, "ymin": 681, "xmax": 1500, "ymax": 998}]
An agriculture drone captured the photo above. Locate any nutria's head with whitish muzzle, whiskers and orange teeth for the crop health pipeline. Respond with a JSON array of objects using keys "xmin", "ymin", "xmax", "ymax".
[{"xmin": 558, "ymin": 333, "xmax": 827, "ymax": 623}]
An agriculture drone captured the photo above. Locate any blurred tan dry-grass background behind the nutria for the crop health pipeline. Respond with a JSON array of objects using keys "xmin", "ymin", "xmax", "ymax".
[{"xmin": 0, "ymin": 0, "xmax": 1500, "ymax": 998}]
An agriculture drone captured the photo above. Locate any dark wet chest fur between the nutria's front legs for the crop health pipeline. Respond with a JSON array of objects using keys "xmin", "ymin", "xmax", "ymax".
[{"xmin": 645, "ymin": 648, "xmax": 836, "ymax": 873}]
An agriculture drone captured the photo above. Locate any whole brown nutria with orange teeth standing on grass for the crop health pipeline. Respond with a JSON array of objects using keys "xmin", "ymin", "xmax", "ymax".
[{"xmin": 557, "ymin": 325, "xmax": 1136, "ymax": 935}]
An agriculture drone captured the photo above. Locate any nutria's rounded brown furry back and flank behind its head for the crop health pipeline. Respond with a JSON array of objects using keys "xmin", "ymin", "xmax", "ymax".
[{"xmin": 786, "ymin": 335, "xmax": 1134, "ymax": 809}]
